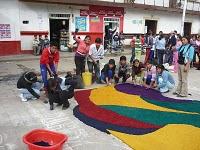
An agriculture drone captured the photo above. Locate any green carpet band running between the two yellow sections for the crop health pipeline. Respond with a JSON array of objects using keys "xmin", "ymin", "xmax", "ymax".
[{"xmin": 101, "ymin": 105, "xmax": 200, "ymax": 127}]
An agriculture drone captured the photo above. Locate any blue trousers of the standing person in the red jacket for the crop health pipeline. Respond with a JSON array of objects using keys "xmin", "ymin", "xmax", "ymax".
[{"xmin": 40, "ymin": 64, "xmax": 56, "ymax": 88}]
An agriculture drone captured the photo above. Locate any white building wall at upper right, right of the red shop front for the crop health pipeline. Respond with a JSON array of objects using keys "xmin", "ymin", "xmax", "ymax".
[{"xmin": 123, "ymin": 9, "xmax": 200, "ymax": 34}]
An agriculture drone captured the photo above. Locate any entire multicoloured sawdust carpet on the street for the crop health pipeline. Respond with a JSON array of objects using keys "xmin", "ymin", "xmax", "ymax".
[{"xmin": 74, "ymin": 83, "xmax": 200, "ymax": 150}]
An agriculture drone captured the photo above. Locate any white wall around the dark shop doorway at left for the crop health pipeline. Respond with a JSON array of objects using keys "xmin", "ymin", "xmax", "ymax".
[{"xmin": 20, "ymin": 2, "xmax": 89, "ymax": 50}]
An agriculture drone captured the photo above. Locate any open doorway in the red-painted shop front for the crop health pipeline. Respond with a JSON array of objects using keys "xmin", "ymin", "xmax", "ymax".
[{"xmin": 103, "ymin": 17, "xmax": 120, "ymax": 47}]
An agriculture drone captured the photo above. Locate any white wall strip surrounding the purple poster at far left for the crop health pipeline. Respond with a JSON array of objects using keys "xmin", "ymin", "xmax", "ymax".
[{"xmin": 0, "ymin": 0, "xmax": 20, "ymax": 41}]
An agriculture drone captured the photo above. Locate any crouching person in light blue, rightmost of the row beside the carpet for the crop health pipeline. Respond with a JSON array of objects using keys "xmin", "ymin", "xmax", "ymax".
[{"xmin": 157, "ymin": 65, "xmax": 175, "ymax": 93}]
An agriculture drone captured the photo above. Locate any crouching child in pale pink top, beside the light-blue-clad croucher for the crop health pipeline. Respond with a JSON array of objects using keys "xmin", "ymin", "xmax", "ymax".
[{"xmin": 144, "ymin": 61, "xmax": 156, "ymax": 88}]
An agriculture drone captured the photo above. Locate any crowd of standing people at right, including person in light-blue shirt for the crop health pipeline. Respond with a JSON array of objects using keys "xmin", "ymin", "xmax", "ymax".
[{"xmin": 131, "ymin": 31, "xmax": 200, "ymax": 97}]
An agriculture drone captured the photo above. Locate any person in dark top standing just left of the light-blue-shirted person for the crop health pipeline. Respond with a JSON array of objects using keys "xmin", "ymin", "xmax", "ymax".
[{"xmin": 165, "ymin": 31, "xmax": 176, "ymax": 65}]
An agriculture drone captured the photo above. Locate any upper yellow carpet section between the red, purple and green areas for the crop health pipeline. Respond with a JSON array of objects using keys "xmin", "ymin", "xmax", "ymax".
[{"xmin": 90, "ymin": 86, "xmax": 197, "ymax": 114}]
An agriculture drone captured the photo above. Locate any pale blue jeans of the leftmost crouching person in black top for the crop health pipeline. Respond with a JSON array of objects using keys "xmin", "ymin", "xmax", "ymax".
[{"xmin": 20, "ymin": 82, "xmax": 43, "ymax": 99}]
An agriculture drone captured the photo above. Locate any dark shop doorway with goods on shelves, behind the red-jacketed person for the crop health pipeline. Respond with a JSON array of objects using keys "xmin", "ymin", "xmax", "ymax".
[{"xmin": 49, "ymin": 18, "xmax": 69, "ymax": 51}]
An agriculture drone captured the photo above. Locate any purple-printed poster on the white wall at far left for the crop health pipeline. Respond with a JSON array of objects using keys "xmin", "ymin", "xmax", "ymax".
[{"xmin": 0, "ymin": 24, "xmax": 11, "ymax": 39}]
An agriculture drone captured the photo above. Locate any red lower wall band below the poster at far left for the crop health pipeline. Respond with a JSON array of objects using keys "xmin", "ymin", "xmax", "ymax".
[{"xmin": 0, "ymin": 41, "xmax": 21, "ymax": 56}]
